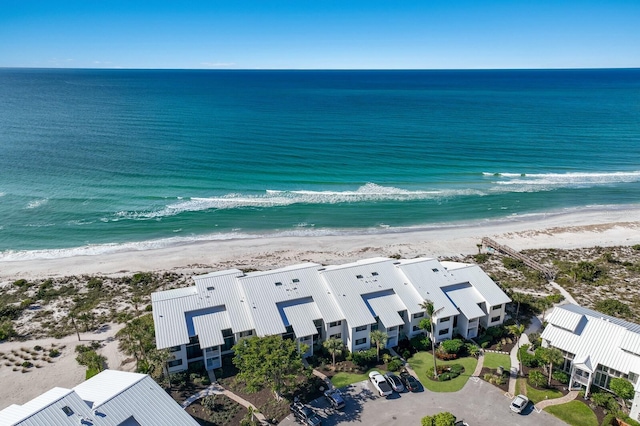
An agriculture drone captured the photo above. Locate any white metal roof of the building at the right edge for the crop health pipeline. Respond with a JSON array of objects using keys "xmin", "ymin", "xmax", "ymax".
[{"xmin": 541, "ymin": 304, "xmax": 640, "ymax": 386}]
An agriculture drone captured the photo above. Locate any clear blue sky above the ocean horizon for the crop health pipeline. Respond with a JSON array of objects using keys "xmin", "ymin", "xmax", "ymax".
[{"xmin": 0, "ymin": 0, "xmax": 640, "ymax": 69}]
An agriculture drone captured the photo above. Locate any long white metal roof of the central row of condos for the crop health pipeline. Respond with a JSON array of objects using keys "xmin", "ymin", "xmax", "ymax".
[{"xmin": 152, "ymin": 258, "xmax": 509, "ymax": 349}]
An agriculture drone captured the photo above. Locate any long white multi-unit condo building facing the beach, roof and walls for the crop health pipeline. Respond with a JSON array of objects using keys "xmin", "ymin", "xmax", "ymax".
[{"xmin": 151, "ymin": 258, "xmax": 510, "ymax": 372}]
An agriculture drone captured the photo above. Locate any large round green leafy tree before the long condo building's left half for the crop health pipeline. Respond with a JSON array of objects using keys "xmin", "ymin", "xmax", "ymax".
[{"xmin": 233, "ymin": 335, "xmax": 305, "ymax": 395}]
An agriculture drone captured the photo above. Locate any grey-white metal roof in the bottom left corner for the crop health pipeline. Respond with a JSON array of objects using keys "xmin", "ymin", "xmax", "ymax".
[{"xmin": 0, "ymin": 370, "xmax": 198, "ymax": 426}]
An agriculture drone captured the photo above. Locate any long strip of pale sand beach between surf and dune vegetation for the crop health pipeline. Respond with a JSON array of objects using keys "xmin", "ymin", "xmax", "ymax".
[{"xmin": 0, "ymin": 205, "xmax": 640, "ymax": 283}]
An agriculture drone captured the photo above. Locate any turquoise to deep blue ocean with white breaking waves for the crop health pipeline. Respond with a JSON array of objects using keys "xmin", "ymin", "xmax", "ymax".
[{"xmin": 0, "ymin": 69, "xmax": 640, "ymax": 260}]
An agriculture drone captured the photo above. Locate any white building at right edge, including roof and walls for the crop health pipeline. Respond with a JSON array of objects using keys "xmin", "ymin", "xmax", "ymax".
[{"xmin": 541, "ymin": 304, "xmax": 640, "ymax": 420}]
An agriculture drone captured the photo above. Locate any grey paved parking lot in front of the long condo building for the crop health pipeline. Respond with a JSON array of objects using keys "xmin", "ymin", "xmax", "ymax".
[{"xmin": 280, "ymin": 379, "xmax": 565, "ymax": 426}]
